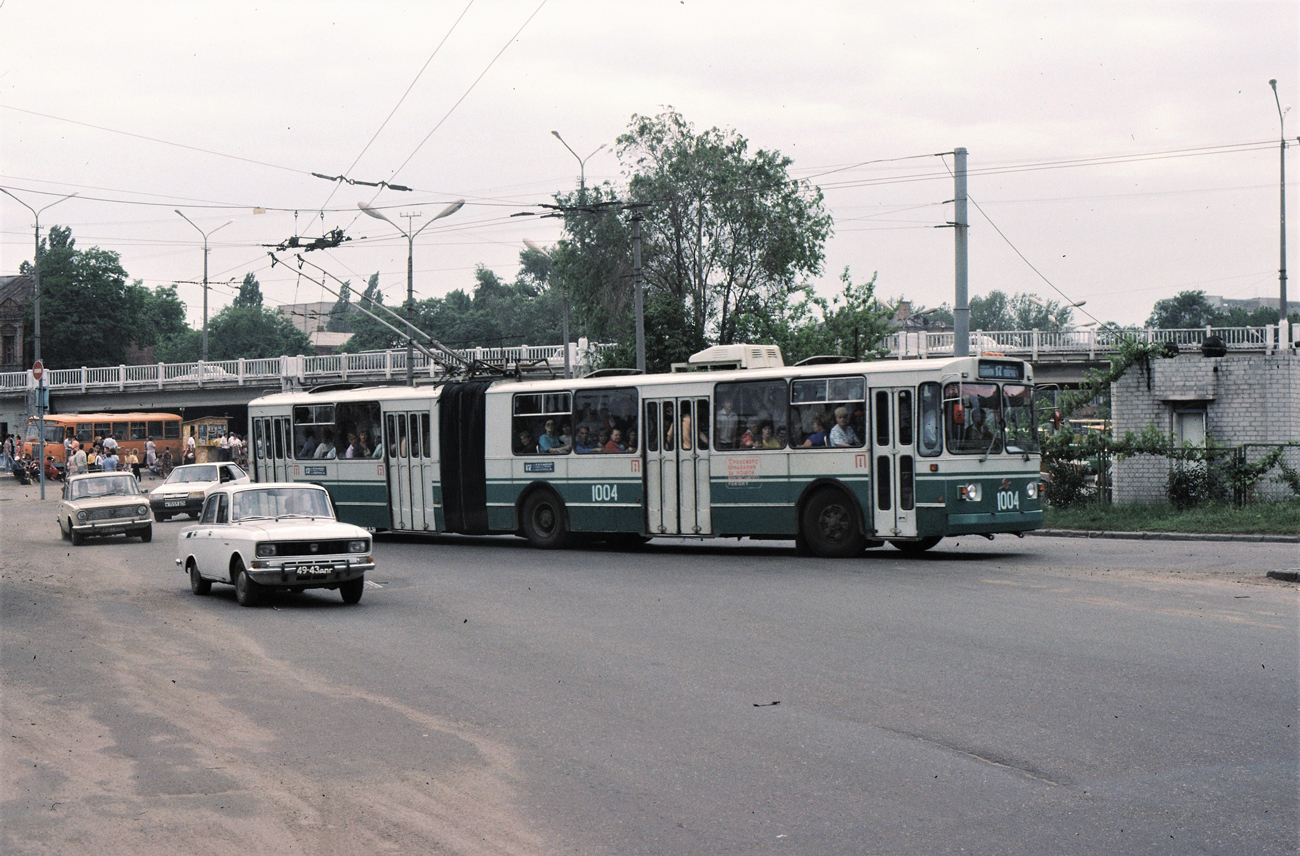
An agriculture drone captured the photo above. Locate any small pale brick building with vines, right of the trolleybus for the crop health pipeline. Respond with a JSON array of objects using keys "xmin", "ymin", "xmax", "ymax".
[{"xmin": 1110, "ymin": 351, "xmax": 1300, "ymax": 502}]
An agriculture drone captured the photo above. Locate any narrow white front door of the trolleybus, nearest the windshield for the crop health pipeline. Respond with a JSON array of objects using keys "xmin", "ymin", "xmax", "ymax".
[{"xmin": 868, "ymin": 389, "xmax": 917, "ymax": 537}]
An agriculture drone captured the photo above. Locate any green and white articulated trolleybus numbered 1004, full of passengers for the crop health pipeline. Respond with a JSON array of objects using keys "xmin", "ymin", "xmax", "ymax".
[{"xmin": 248, "ymin": 346, "xmax": 1043, "ymax": 557}]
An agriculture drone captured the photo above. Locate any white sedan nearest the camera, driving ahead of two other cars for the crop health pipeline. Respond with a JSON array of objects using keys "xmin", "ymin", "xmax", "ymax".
[{"xmin": 176, "ymin": 481, "xmax": 374, "ymax": 606}]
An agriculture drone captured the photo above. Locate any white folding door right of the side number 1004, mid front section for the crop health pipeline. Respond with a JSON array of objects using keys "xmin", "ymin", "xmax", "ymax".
[{"xmin": 644, "ymin": 398, "xmax": 712, "ymax": 535}]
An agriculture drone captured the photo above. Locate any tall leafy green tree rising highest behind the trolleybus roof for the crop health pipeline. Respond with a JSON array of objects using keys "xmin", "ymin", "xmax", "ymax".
[{"xmin": 556, "ymin": 109, "xmax": 831, "ymax": 371}]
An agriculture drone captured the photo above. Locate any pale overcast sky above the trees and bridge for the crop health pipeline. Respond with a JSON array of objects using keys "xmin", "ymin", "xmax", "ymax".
[{"xmin": 0, "ymin": 0, "xmax": 1300, "ymax": 338}]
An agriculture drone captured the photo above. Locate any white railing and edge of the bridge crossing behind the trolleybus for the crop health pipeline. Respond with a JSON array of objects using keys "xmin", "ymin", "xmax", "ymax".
[{"xmin": 0, "ymin": 321, "xmax": 1300, "ymax": 410}]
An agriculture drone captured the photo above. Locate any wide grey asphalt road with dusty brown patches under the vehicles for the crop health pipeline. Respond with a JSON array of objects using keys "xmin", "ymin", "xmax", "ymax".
[{"xmin": 0, "ymin": 479, "xmax": 1300, "ymax": 856}]
